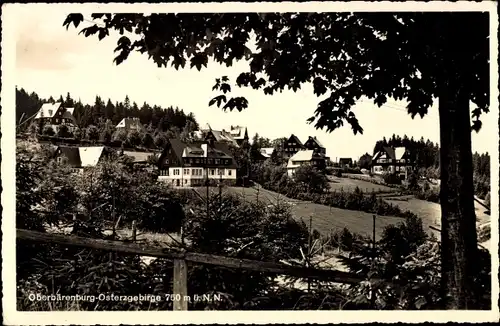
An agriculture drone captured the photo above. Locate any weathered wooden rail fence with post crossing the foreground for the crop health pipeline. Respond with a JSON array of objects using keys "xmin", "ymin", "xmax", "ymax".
[{"xmin": 16, "ymin": 229, "xmax": 364, "ymax": 310}]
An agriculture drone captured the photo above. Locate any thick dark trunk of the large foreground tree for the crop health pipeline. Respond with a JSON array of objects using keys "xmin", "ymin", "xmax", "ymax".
[{"xmin": 439, "ymin": 74, "xmax": 477, "ymax": 309}]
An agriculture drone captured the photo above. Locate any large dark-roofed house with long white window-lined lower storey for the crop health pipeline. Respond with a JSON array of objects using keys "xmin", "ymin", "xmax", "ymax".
[{"xmin": 158, "ymin": 139, "xmax": 237, "ymax": 187}]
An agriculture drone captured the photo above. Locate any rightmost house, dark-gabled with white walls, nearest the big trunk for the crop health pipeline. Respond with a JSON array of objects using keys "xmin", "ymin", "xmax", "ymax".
[{"xmin": 371, "ymin": 147, "xmax": 413, "ymax": 180}]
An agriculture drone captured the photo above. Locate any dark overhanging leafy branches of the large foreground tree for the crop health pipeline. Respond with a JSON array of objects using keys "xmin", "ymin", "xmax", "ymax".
[{"xmin": 64, "ymin": 12, "xmax": 489, "ymax": 133}]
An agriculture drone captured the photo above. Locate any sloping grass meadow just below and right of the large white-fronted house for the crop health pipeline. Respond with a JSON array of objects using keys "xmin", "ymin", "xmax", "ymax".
[{"xmin": 193, "ymin": 187, "xmax": 403, "ymax": 237}]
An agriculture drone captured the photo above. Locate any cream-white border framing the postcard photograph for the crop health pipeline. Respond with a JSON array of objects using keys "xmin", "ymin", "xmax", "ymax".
[{"xmin": 1, "ymin": 1, "xmax": 500, "ymax": 325}]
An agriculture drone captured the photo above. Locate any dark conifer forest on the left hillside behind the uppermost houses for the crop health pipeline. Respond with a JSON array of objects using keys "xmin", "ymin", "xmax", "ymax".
[{"xmin": 16, "ymin": 88, "xmax": 198, "ymax": 148}]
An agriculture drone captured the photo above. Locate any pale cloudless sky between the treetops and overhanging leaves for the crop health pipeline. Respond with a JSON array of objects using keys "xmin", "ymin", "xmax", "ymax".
[{"xmin": 15, "ymin": 5, "xmax": 498, "ymax": 160}]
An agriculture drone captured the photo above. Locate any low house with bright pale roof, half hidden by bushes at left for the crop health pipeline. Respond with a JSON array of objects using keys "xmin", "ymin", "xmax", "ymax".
[{"xmin": 54, "ymin": 146, "xmax": 110, "ymax": 172}]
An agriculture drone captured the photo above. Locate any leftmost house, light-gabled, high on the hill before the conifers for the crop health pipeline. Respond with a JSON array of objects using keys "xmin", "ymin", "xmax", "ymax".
[{"xmin": 34, "ymin": 102, "xmax": 77, "ymax": 132}]
